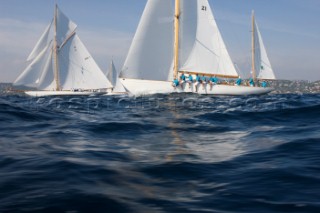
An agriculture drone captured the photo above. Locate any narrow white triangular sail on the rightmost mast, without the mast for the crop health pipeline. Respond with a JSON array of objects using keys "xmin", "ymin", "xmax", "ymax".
[{"xmin": 254, "ymin": 19, "xmax": 276, "ymax": 80}]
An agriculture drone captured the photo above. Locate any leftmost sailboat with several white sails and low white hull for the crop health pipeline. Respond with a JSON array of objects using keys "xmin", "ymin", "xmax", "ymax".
[{"xmin": 14, "ymin": 5, "xmax": 112, "ymax": 96}]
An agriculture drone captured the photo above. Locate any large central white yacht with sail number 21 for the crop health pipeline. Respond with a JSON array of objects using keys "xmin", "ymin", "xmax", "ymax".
[{"xmin": 120, "ymin": 0, "xmax": 272, "ymax": 95}]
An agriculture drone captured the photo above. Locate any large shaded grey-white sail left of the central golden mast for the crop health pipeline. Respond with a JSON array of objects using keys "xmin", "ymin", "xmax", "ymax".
[{"xmin": 120, "ymin": 0, "xmax": 173, "ymax": 81}]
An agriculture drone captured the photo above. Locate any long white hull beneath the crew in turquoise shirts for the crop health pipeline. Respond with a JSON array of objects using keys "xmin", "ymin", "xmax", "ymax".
[{"xmin": 120, "ymin": 79, "xmax": 273, "ymax": 95}]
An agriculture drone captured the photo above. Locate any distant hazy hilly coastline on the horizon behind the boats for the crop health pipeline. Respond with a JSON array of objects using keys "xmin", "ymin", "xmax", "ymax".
[{"xmin": 0, "ymin": 80, "xmax": 320, "ymax": 94}]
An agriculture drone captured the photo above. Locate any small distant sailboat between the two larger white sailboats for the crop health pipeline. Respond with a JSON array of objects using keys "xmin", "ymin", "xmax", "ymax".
[{"xmin": 107, "ymin": 60, "xmax": 127, "ymax": 95}]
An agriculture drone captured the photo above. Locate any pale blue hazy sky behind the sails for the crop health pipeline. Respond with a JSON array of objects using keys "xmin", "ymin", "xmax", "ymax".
[{"xmin": 0, "ymin": 0, "xmax": 320, "ymax": 82}]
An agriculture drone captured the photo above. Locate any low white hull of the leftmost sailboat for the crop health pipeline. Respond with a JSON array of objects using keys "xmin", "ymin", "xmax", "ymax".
[{"xmin": 25, "ymin": 91, "xmax": 105, "ymax": 97}]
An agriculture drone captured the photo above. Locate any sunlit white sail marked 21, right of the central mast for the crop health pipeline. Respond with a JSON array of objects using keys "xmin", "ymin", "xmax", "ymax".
[{"xmin": 180, "ymin": 0, "xmax": 238, "ymax": 77}]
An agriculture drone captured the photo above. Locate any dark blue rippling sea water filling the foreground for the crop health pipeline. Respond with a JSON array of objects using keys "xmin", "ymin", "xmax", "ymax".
[{"xmin": 0, "ymin": 94, "xmax": 320, "ymax": 213}]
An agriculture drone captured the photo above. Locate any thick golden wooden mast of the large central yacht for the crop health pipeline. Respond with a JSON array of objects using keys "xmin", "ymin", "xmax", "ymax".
[{"xmin": 173, "ymin": 0, "xmax": 180, "ymax": 79}]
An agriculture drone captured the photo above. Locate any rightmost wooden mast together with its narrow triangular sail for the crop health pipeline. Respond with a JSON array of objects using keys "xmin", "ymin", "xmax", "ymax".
[{"xmin": 252, "ymin": 11, "xmax": 276, "ymax": 80}]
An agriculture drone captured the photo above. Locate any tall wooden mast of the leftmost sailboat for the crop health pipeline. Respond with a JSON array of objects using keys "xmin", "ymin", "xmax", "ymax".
[{"xmin": 53, "ymin": 4, "xmax": 60, "ymax": 91}]
